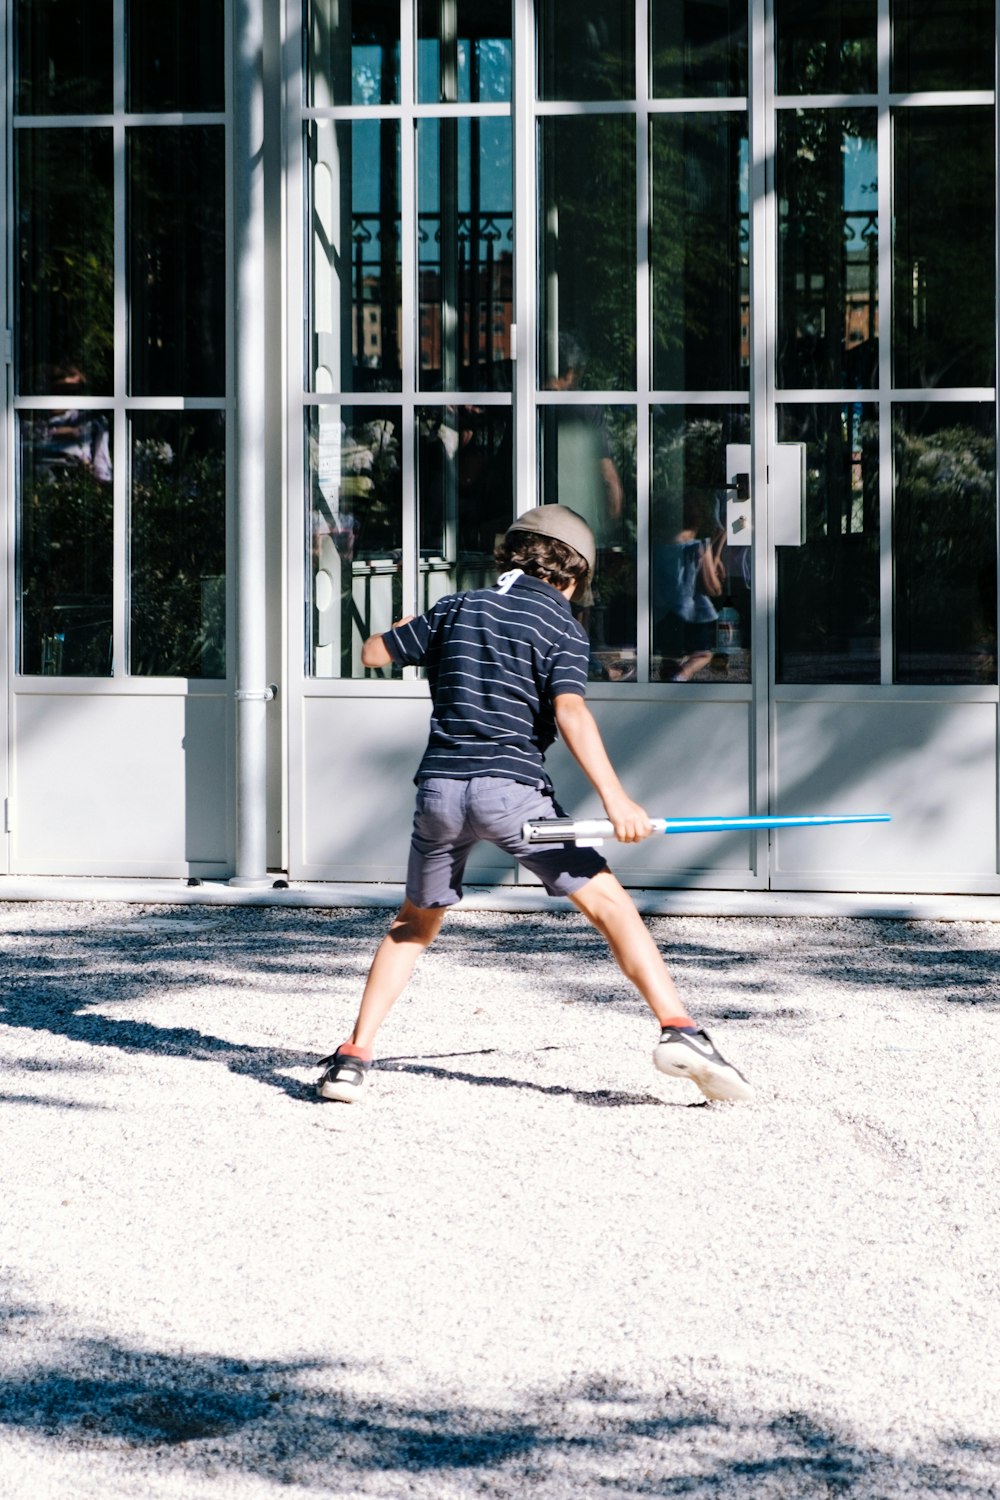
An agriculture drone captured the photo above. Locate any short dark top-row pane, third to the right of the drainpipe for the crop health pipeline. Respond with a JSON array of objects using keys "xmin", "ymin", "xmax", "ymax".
[{"xmin": 538, "ymin": 0, "xmax": 636, "ymax": 99}]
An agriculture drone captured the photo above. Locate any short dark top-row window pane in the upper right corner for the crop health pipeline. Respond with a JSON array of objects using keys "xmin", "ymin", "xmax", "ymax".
[{"xmin": 889, "ymin": 0, "xmax": 994, "ymax": 93}]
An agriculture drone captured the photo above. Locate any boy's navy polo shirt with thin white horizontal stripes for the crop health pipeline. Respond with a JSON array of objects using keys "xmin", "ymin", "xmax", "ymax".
[{"xmin": 382, "ymin": 573, "xmax": 589, "ymax": 788}]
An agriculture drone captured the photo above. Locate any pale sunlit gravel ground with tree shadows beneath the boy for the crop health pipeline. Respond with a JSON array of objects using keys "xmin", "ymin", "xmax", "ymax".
[{"xmin": 0, "ymin": 903, "xmax": 1000, "ymax": 1500}]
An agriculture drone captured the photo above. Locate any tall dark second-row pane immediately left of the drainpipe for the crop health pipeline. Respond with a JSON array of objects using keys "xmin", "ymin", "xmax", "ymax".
[{"xmin": 127, "ymin": 125, "xmax": 226, "ymax": 396}]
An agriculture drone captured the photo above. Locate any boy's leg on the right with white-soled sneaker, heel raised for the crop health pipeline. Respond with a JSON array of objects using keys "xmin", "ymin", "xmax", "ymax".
[{"xmin": 570, "ymin": 870, "xmax": 754, "ymax": 1100}]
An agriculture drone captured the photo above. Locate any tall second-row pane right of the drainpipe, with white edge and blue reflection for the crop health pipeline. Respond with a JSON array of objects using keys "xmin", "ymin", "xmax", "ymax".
[{"xmin": 307, "ymin": 120, "xmax": 402, "ymax": 392}]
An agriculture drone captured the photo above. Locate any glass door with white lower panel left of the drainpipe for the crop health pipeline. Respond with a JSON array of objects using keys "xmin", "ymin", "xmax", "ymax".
[{"xmin": 9, "ymin": 0, "xmax": 231, "ymax": 875}]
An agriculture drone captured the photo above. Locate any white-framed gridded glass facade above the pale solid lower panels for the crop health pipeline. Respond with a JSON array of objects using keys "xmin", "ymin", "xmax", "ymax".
[{"xmin": 7, "ymin": 0, "xmax": 997, "ymax": 876}]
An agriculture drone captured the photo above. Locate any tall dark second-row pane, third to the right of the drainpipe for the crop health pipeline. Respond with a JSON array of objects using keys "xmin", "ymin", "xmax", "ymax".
[{"xmin": 538, "ymin": 114, "xmax": 636, "ymax": 390}]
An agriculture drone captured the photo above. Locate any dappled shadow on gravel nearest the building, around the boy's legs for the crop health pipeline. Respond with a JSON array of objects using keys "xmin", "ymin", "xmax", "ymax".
[{"xmin": 0, "ymin": 908, "xmax": 1000, "ymax": 1106}]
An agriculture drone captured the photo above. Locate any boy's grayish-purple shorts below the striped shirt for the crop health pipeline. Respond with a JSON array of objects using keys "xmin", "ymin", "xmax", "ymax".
[{"xmin": 406, "ymin": 776, "xmax": 607, "ymax": 908}]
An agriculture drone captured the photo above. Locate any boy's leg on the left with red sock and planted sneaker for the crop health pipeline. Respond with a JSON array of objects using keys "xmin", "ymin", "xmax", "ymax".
[{"xmin": 316, "ymin": 899, "xmax": 447, "ymax": 1104}]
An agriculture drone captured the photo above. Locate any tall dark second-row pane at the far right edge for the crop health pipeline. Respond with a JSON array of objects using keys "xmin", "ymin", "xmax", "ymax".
[{"xmin": 892, "ymin": 107, "xmax": 996, "ymax": 387}]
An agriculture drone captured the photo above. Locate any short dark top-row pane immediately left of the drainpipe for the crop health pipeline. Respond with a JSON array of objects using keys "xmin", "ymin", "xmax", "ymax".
[{"xmin": 126, "ymin": 0, "xmax": 226, "ymax": 113}]
